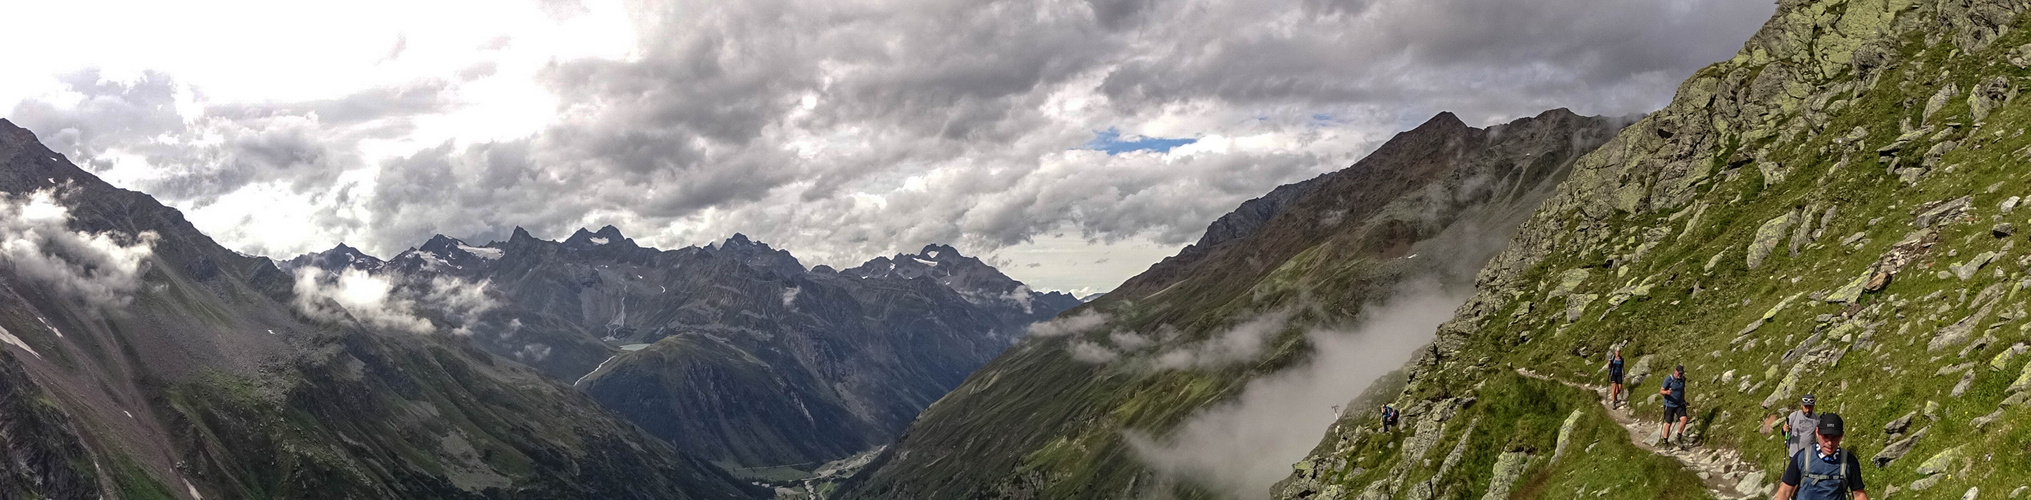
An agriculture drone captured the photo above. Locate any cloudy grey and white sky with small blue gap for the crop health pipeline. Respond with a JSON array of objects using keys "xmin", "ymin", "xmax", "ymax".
[{"xmin": 0, "ymin": 0, "xmax": 1773, "ymax": 291}]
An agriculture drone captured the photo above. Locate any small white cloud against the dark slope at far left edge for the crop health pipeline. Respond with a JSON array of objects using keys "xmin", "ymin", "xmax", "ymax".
[{"xmin": 0, "ymin": 189, "xmax": 156, "ymax": 307}]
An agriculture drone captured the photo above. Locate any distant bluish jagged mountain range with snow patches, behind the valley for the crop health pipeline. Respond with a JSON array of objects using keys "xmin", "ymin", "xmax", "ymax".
[{"xmin": 290, "ymin": 226, "xmax": 1078, "ymax": 467}]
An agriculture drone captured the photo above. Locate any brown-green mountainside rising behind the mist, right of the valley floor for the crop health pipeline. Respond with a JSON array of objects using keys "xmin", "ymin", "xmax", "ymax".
[{"xmin": 847, "ymin": 110, "xmax": 1619, "ymax": 498}]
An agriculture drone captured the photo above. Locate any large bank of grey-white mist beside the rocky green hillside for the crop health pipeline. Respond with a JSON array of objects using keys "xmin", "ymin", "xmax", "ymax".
[{"xmin": 1127, "ymin": 280, "xmax": 1466, "ymax": 500}]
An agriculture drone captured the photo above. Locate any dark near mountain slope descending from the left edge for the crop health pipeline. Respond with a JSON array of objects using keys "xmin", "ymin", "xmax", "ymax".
[{"xmin": 0, "ymin": 120, "xmax": 754, "ymax": 498}]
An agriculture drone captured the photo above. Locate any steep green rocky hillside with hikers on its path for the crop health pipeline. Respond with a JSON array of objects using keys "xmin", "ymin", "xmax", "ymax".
[{"xmin": 1275, "ymin": 0, "xmax": 2031, "ymax": 498}]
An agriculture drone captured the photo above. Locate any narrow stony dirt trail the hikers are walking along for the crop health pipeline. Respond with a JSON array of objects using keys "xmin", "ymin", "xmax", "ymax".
[{"xmin": 1517, "ymin": 368, "xmax": 1777, "ymax": 500}]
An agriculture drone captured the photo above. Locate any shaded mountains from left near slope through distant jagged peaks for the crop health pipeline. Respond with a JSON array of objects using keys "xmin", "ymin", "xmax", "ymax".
[{"xmin": 0, "ymin": 115, "xmax": 1078, "ymax": 498}]
